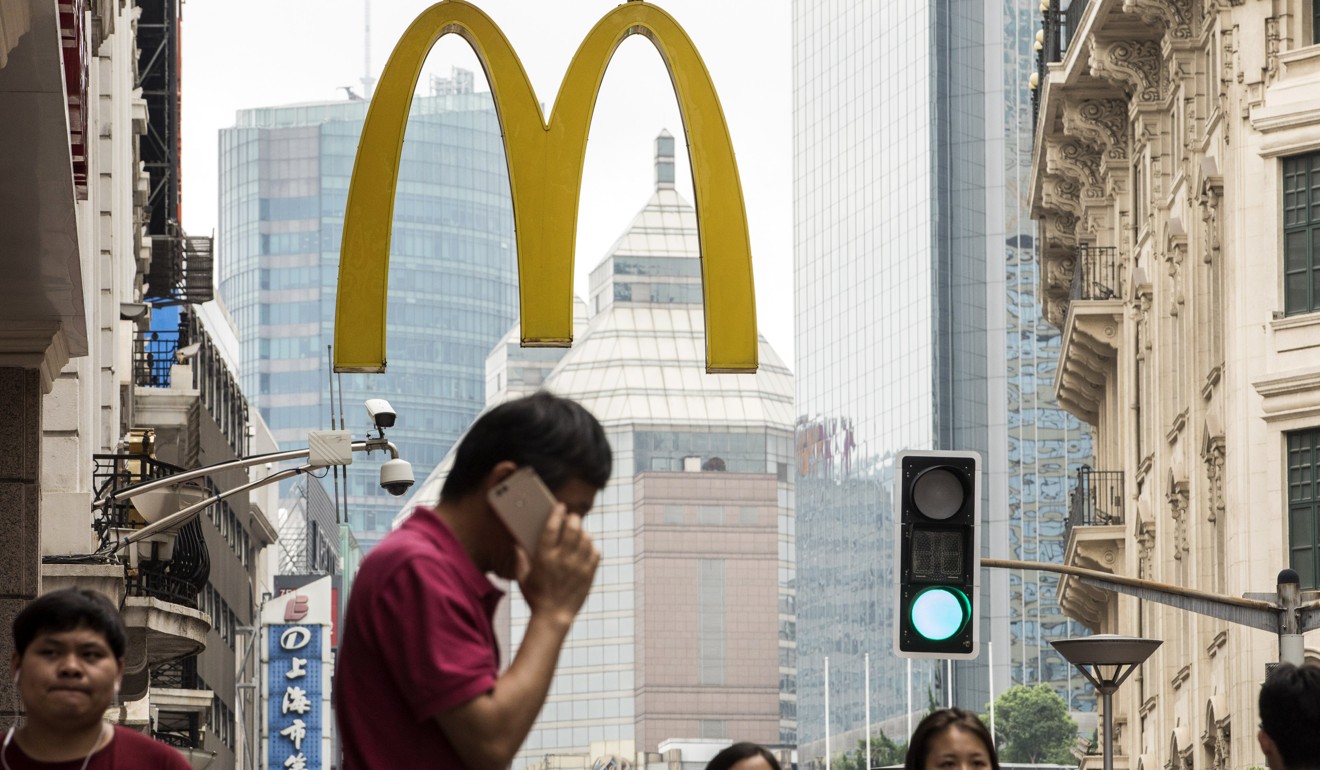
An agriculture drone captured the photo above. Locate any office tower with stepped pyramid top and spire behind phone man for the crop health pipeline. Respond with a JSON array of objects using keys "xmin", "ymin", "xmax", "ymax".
[{"xmin": 414, "ymin": 133, "xmax": 796, "ymax": 769}]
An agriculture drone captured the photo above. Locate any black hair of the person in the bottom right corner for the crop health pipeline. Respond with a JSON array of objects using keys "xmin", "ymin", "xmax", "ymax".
[{"xmin": 1261, "ymin": 663, "xmax": 1320, "ymax": 770}]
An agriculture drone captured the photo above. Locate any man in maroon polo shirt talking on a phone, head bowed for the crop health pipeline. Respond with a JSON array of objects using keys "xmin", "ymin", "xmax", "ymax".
[{"xmin": 335, "ymin": 391, "xmax": 612, "ymax": 770}]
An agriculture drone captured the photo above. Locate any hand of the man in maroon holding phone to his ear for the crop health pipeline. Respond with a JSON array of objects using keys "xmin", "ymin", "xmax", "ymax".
[{"xmin": 517, "ymin": 503, "xmax": 601, "ymax": 625}]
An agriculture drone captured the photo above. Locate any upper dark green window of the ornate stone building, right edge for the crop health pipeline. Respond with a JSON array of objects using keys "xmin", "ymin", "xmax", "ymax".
[{"xmin": 1283, "ymin": 152, "xmax": 1320, "ymax": 316}]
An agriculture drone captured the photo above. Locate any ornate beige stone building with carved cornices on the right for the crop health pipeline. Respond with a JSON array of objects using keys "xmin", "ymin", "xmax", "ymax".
[{"xmin": 1032, "ymin": 0, "xmax": 1320, "ymax": 770}]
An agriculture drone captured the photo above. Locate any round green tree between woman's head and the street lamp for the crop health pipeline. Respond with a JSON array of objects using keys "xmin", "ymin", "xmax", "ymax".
[{"xmin": 994, "ymin": 684, "xmax": 1077, "ymax": 765}]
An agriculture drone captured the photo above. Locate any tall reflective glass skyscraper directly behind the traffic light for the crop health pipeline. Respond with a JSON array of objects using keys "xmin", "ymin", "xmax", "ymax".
[{"xmin": 793, "ymin": 0, "xmax": 1086, "ymax": 761}]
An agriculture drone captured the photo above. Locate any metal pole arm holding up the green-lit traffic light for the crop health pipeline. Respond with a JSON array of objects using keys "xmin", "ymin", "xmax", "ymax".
[{"xmin": 981, "ymin": 559, "xmax": 1320, "ymax": 666}]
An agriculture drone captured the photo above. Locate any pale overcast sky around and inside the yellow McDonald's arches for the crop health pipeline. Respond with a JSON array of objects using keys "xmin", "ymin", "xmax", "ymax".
[{"xmin": 182, "ymin": 0, "xmax": 793, "ymax": 367}]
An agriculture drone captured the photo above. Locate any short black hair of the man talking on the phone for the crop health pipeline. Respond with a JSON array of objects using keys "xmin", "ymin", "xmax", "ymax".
[{"xmin": 440, "ymin": 391, "xmax": 614, "ymax": 502}]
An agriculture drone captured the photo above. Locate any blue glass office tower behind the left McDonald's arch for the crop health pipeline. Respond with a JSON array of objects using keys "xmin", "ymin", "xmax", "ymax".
[{"xmin": 219, "ymin": 73, "xmax": 517, "ymax": 549}]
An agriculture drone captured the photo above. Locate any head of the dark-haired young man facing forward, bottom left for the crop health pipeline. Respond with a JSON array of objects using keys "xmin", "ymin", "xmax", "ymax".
[{"xmin": 12, "ymin": 588, "xmax": 128, "ymax": 728}]
